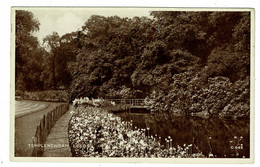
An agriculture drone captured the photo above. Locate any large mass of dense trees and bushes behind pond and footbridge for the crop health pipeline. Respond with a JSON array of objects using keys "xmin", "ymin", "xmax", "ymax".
[{"xmin": 66, "ymin": 11, "xmax": 250, "ymax": 116}]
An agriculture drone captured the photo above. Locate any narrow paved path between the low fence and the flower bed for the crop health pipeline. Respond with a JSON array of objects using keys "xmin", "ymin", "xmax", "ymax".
[{"xmin": 43, "ymin": 106, "xmax": 74, "ymax": 157}]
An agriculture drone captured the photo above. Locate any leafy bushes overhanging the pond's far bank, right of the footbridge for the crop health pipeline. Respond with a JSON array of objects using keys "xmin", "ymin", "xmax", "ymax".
[{"xmin": 145, "ymin": 71, "xmax": 250, "ymax": 117}]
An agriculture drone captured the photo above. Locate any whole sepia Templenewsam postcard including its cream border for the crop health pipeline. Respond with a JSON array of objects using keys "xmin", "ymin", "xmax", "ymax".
[{"xmin": 11, "ymin": 7, "xmax": 254, "ymax": 163}]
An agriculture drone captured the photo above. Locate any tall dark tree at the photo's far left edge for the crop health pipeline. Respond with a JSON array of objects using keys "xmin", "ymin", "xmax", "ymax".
[{"xmin": 15, "ymin": 10, "xmax": 40, "ymax": 90}]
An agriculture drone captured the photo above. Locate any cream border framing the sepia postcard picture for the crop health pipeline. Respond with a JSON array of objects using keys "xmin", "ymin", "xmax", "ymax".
[{"xmin": 10, "ymin": 7, "xmax": 254, "ymax": 163}]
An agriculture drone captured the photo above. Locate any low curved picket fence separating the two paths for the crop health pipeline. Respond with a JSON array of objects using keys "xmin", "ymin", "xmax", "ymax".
[{"xmin": 32, "ymin": 103, "xmax": 69, "ymax": 157}]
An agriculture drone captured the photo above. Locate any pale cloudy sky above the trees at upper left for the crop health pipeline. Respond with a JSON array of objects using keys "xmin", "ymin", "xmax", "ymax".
[{"xmin": 27, "ymin": 8, "xmax": 151, "ymax": 44}]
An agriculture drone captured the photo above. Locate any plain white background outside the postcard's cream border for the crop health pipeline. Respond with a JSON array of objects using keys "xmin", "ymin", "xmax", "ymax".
[{"xmin": 0, "ymin": 0, "xmax": 259, "ymax": 166}]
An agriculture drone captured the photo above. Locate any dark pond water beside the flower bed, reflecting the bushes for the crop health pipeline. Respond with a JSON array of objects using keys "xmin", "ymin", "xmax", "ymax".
[{"xmin": 116, "ymin": 109, "xmax": 250, "ymax": 158}]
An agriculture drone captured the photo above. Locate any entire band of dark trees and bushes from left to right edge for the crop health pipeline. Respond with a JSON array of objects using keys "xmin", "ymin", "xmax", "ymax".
[{"xmin": 16, "ymin": 11, "xmax": 250, "ymax": 117}]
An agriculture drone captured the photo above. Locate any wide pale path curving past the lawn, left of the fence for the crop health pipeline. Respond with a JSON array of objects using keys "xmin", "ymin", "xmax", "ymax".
[{"xmin": 14, "ymin": 100, "xmax": 64, "ymax": 157}]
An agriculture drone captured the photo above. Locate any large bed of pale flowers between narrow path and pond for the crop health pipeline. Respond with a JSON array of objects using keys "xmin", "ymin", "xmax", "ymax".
[{"xmin": 68, "ymin": 106, "xmax": 204, "ymax": 158}]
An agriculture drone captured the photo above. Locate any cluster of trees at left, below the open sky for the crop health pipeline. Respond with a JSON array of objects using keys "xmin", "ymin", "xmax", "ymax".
[{"xmin": 15, "ymin": 10, "xmax": 79, "ymax": 92}]
